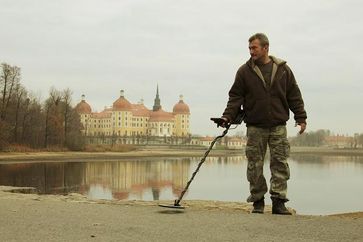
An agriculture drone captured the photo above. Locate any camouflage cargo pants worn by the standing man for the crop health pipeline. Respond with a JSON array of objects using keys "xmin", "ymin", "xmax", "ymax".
[{"xmin": 246, "ymin": 125, "xmax": 290, "ymax": 202}]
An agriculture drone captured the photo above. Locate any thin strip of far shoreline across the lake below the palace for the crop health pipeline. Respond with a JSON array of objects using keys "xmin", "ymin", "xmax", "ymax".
[{"xmin": 0, "ymin": 147, "xmax": 363, "ymax": 163}]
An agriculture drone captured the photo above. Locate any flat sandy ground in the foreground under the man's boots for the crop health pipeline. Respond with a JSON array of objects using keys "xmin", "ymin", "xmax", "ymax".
[{"xmin": 0, "ymin": 187, "xmax": 363, "ymax": 241}]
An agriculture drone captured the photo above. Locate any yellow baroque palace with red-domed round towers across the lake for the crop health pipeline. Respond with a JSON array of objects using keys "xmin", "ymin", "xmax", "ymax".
[{"xmin": 76, "ymin": 87, "xmax": 190, "ymax": 137}]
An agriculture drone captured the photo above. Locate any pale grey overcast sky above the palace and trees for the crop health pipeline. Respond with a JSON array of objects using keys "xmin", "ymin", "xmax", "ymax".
[{"xmin": 0, "ymin": 0, "xmax": 363, "ymax": 136}]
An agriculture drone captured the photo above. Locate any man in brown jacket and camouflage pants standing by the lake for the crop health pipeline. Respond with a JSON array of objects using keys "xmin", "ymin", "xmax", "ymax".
[{"xmin": 222, "ymin": 33, "xmax": 307, "ymax": 215}]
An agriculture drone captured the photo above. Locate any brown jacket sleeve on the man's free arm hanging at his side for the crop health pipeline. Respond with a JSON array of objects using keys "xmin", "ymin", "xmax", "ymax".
[{"xmin": 286, "ymin": 65, "xmax": 307, "ymax": 123}]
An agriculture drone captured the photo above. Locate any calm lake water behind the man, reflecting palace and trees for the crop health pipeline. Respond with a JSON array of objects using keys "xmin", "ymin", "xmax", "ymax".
[{"xmin": 0, "ymin": 155, "xmax": 363, "ymax": 215}]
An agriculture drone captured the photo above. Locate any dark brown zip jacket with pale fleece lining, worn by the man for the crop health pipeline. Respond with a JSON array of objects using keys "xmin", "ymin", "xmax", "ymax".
[{"xmin": 223, "ymin": 56, "xmax": 306, "ymax": 127}]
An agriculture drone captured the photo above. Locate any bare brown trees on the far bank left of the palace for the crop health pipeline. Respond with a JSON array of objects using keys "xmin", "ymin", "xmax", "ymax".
[{"xmin": 0, "ymin": 63, "xmax": 84, "ymax": 150}]
